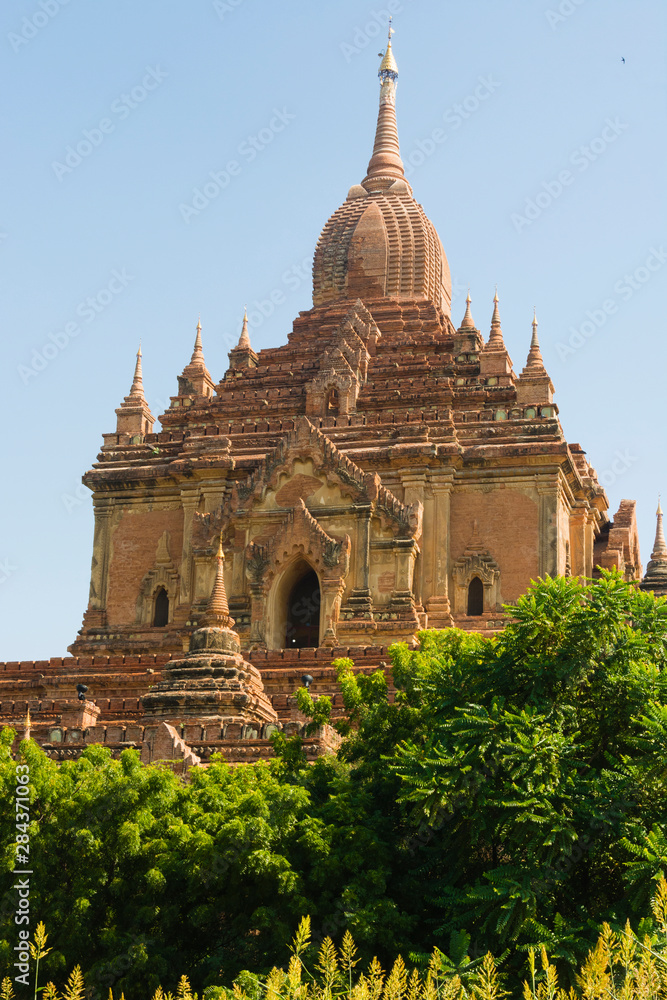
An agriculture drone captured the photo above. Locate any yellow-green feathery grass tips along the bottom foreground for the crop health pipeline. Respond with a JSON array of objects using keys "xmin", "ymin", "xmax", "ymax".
[{"xmin": 6, "ymin": 878, "xmax": 667, "ymax": 1000}]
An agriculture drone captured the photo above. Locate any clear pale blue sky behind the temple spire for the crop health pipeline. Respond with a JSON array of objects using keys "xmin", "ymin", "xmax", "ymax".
[{"xmin": 0, "ymin": 0, "xmax": 667, "ymax": 659}]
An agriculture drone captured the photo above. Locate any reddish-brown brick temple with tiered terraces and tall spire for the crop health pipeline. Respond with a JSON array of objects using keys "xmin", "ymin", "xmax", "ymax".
[{"xmin": 0, "ymin": 34, "xmax": 667, "ymax": 766}]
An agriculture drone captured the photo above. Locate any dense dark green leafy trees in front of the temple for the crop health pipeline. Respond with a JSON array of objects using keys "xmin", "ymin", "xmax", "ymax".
[{"xmin": 0, "ymin": 575, "xmax": 667, "ymax": 1000}]
